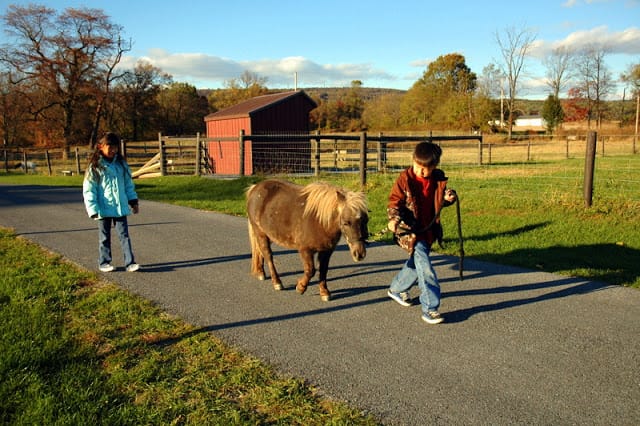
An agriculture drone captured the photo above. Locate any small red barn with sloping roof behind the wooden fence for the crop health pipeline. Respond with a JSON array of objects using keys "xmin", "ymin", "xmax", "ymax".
[{"xmin": 204, "ymin": 91, "xmax": 317, "ymax": 175}]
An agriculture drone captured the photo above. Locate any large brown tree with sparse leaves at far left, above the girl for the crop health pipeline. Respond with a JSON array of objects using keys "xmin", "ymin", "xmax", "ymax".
[{"xmin": 0, "ymin": 4, "xmax": 128, "ymax": 154}]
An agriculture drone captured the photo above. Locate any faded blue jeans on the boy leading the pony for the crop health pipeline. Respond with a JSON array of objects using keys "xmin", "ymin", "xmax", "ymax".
[{"xmin": 389, "ymin": 241, "xmax": 440, "ymax": 313}]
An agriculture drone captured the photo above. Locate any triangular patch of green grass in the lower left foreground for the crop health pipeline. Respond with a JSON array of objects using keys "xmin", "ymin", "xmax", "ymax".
[{"xmin": 0, "ymin": 229, "xmax": 376, "ymax": 425}]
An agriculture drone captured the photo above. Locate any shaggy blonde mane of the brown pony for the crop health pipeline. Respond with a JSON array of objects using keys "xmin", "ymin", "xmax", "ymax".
[{"xmin": 301, "ymin": 182, "xmax": 368, "ymax": 228}]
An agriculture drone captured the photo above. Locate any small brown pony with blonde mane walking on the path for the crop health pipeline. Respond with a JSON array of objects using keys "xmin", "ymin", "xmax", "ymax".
[{"xmin": 247, "ymin": 179, "xmax": 369, "ymax": 301}]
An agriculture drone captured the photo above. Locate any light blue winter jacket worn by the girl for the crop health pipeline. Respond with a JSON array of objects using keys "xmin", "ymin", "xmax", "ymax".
[{"xmin": 82, "ymin": 154, "xmax": 138, "ymax": 219}]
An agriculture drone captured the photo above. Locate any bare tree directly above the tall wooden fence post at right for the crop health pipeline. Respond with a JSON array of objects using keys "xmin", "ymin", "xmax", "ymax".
[{"xmin": 577, "ymin": 45, "xmax": 613, "ymax": 128}]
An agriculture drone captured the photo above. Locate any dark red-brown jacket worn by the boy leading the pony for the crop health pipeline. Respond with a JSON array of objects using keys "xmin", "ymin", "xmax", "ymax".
[{"xmin": 387, "ymin": 167, "xmax": 452, "ymax": 246}]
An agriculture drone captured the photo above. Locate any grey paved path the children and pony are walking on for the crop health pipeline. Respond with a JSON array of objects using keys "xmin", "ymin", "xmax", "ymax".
[{"xmin": 0, "ymin": 185, "xmax": 640, "ymax": 425}]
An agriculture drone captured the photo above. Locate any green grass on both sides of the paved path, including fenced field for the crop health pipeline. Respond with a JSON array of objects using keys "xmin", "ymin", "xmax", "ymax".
[{"xmin": 0, "ymin": 153, "xmax": 640, "ymax": 424}]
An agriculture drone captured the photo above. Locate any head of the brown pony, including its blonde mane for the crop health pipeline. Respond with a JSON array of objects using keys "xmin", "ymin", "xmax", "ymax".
[{"xmin": 303, "ymin": 182, "xmax": 369, "ymax": 262}]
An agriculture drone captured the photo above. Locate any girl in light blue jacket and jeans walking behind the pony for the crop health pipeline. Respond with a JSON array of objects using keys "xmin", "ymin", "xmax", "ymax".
[{"xmin": 82, "ymin": 133, "xmax": 140, "ymax": 272}]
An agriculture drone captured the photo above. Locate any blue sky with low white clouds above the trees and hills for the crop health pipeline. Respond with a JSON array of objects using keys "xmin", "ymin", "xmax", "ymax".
[{"xmin": 0, "ymin": 0, "xmax": 640, "ymax": 98}]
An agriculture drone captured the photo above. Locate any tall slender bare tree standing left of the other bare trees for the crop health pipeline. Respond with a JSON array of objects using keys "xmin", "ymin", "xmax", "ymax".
[{"xmin": 495, "ymin": 27, "xmax": 536, "ymax": 139}]
